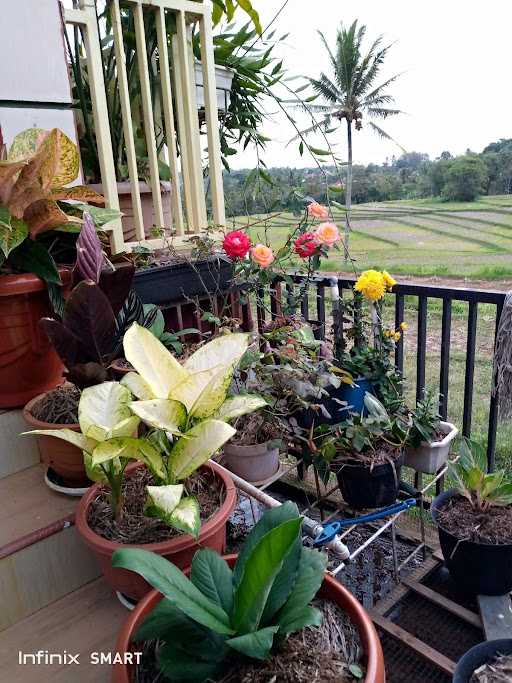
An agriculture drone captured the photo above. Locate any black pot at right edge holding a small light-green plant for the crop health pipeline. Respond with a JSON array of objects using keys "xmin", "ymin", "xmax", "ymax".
[{"xmin": 431, "ymin": 489, "xmax": 512, "ymax": 595}]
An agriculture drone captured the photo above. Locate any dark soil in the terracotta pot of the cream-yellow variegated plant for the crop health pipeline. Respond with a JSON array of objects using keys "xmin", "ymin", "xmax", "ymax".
[{"xmin": 87, "ymin": 468, "xmax": 224, "ymax": 545}]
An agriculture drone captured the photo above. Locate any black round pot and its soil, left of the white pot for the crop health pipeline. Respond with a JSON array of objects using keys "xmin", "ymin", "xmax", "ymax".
[{"xmin": 332, "ymin": 449, "xmax": 403, "ymax": 510}]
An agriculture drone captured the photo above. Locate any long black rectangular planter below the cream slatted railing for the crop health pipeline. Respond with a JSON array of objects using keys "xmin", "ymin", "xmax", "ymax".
[{"xmin": 133, "ymin": 257, "xmax": 233, "ymax": 306}]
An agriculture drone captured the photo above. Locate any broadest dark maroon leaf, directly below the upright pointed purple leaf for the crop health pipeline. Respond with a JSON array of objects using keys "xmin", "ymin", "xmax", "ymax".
[{"xmin": 62, "ymin": 282, "xmax": 116, "ymax": 369}]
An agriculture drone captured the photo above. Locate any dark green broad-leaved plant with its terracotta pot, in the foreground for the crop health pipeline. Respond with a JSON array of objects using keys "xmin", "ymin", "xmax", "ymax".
[{"xmin": 112, "ymin": 503, "xmax": 385, "ymax": 683}]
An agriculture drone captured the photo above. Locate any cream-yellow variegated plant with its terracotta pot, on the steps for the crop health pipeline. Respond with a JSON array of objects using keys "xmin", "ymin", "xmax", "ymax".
[{"xmin": 24, "ymin": 323, "xmax": 263, "ymax": 599}]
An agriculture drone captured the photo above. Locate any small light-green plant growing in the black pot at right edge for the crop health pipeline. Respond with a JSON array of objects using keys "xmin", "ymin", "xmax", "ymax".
[{"xmin": 448, "ymin": 439, "xmax": 512, "ymax": 512}]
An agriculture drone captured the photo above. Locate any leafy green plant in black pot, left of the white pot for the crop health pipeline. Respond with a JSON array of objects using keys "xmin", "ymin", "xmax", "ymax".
[{"xmin": 313, "ymin": 393, "xmax": 409, "ymax": 510}]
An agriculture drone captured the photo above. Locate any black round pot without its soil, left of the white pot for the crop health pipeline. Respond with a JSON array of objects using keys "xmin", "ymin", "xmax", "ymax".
[{"xmin": 336, "ymin": 455, "xmax": 403, "ymax": 510}]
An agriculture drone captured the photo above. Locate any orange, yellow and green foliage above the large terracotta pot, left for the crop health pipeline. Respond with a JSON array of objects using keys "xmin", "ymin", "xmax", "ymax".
[{"xmin": 0, "ymin": 128, "xmax": 114, "ymax": 284}]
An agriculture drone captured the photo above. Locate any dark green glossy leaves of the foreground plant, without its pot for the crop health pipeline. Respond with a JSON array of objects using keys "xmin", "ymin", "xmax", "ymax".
[{"xmin": 112, "ymin": 502, "xmax": 327, "ymax": 682}]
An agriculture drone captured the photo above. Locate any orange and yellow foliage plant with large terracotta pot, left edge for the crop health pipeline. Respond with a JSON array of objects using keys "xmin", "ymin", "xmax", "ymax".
[{"xmin": 0, "ymin": 128, "xmax": 113, "ymax": 408}]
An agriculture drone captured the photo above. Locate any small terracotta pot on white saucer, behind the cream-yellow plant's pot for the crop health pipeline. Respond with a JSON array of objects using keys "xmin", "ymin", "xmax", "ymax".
[{"xmin": 23, "ymin": 392, "xmax": 91, "ymax": 488}]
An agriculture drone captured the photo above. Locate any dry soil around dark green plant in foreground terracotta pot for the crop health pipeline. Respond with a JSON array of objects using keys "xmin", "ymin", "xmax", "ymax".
[{"xmin": 134, "ymin": 599, "xmax": 364, "ymax": 683}]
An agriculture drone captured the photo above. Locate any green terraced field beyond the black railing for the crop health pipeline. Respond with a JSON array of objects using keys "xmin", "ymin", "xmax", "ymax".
[{"xmin": 231, "ymin": 195, "xmax": 512, "ymax": 280}]
